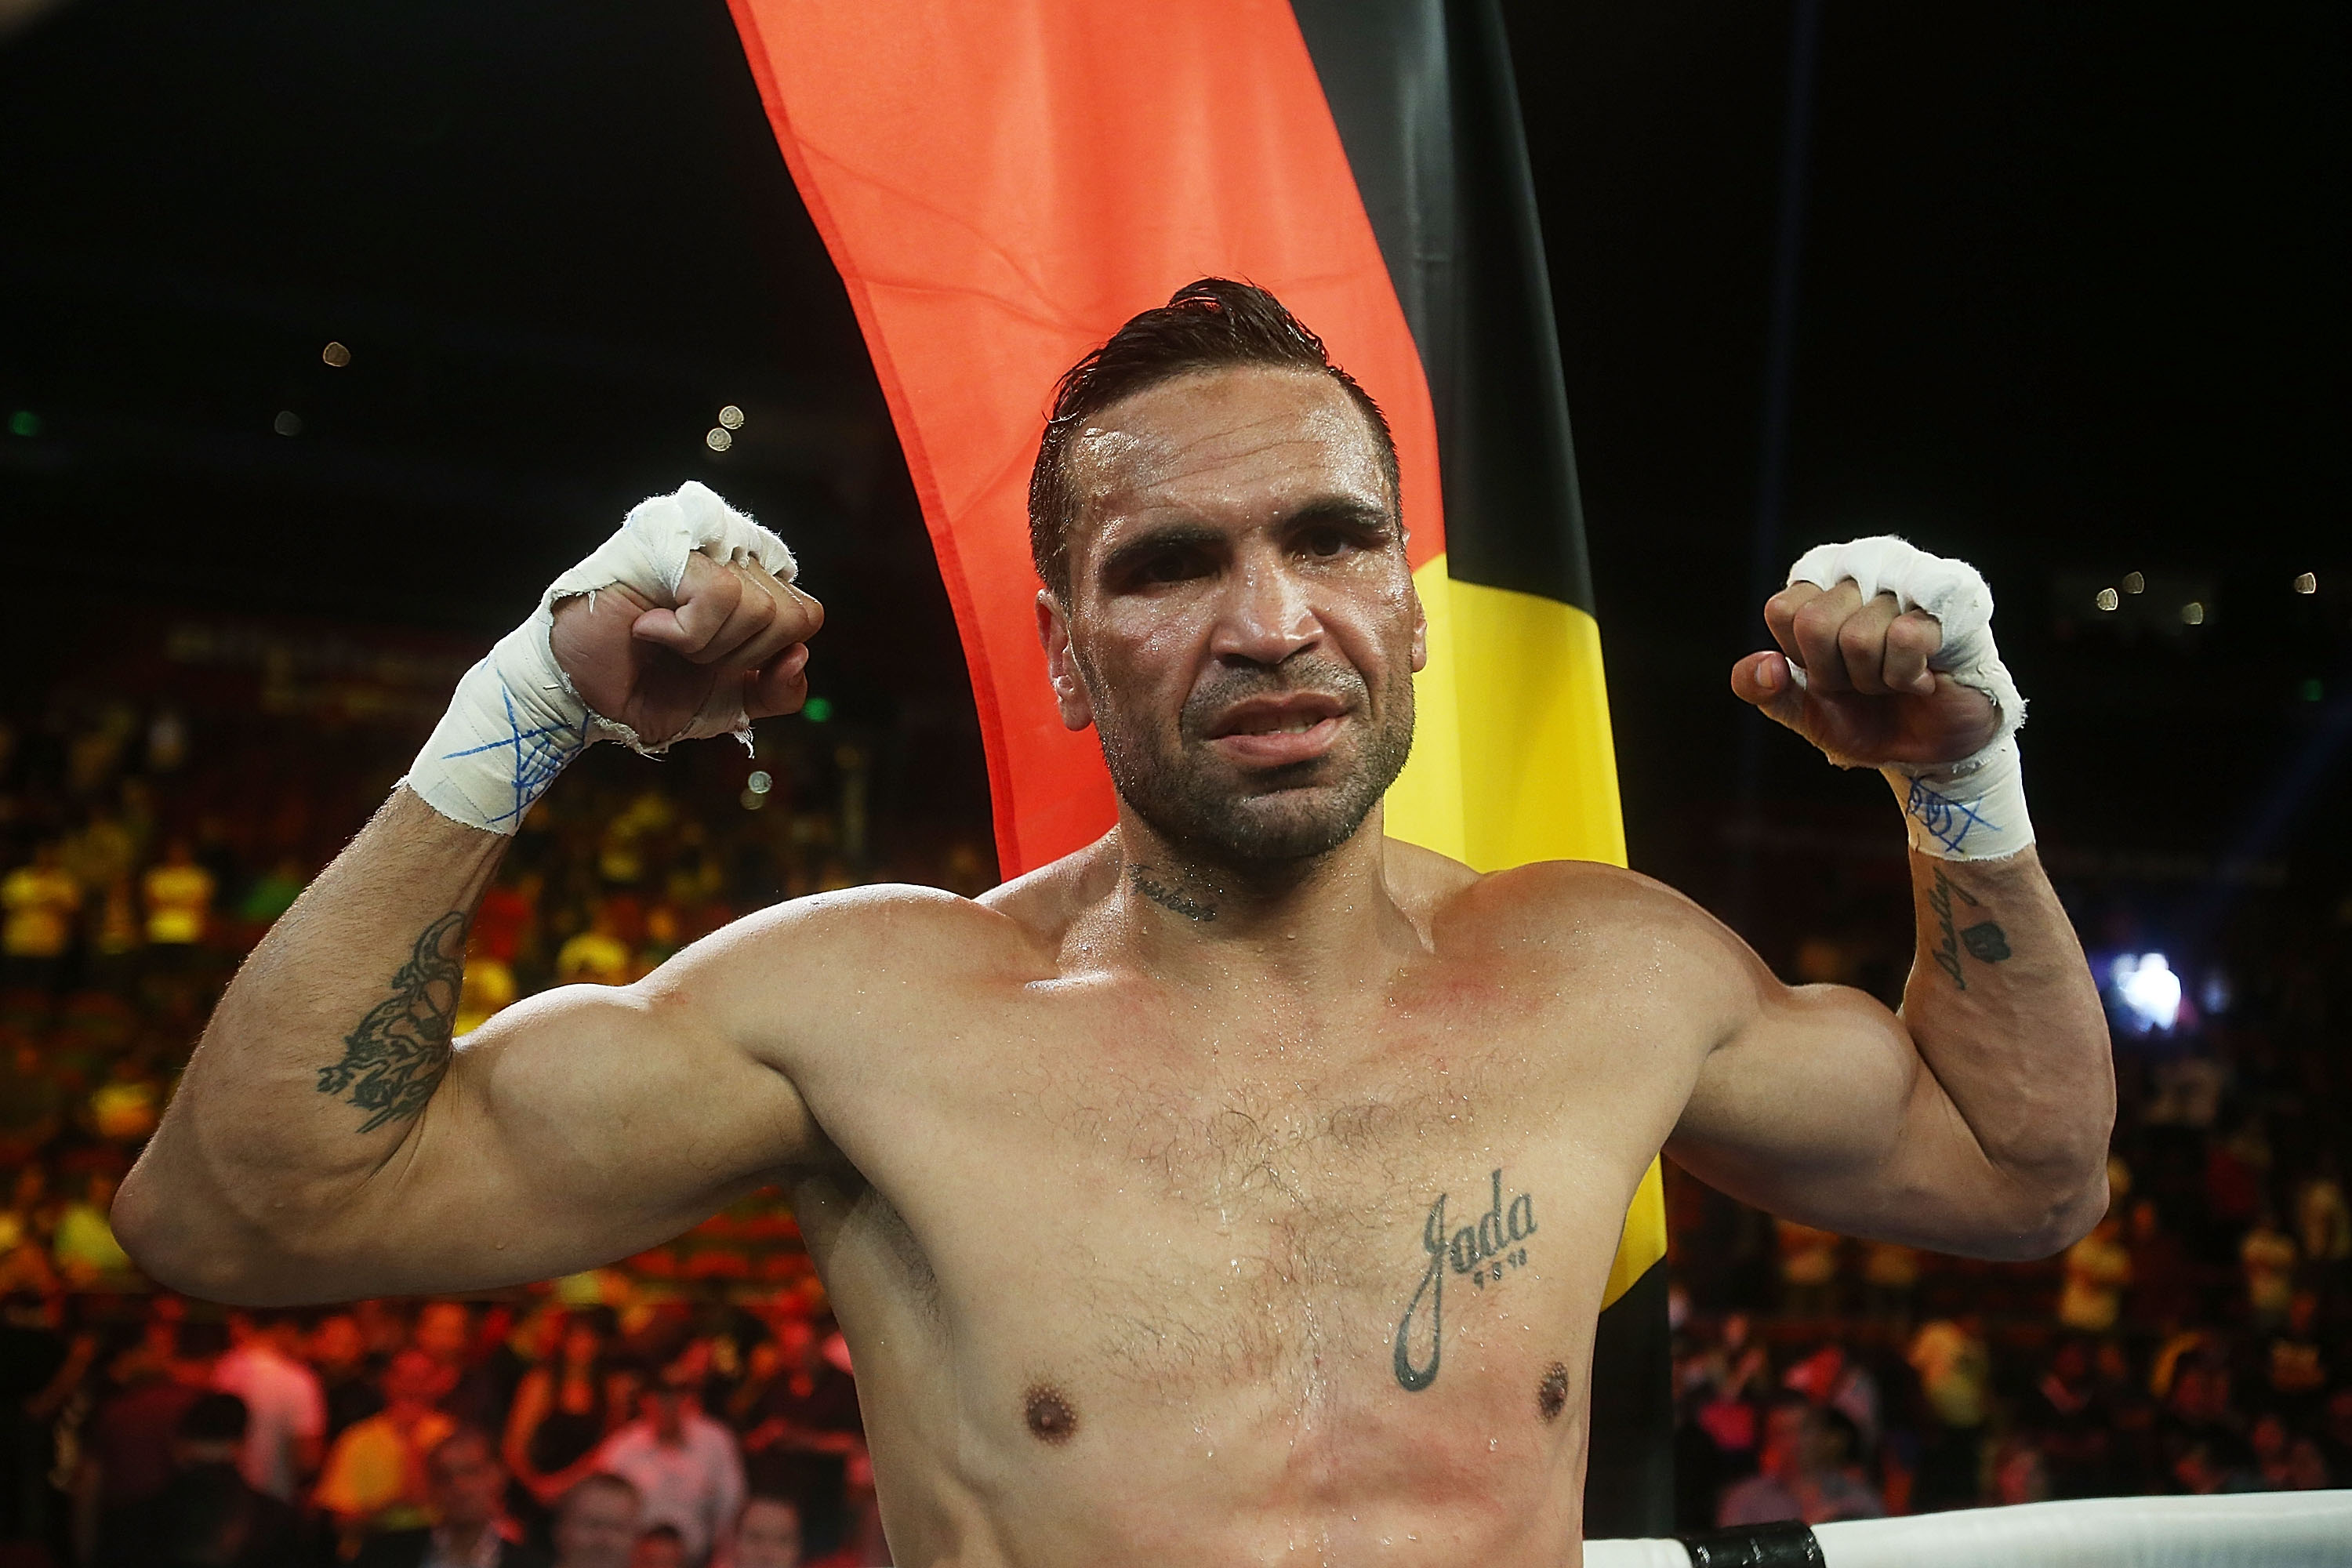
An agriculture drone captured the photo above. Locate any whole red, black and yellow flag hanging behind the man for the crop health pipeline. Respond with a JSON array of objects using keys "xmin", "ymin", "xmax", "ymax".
[{"xmin": 731, "ymin": 0, "xmax": 1672, "ymax": 1535}]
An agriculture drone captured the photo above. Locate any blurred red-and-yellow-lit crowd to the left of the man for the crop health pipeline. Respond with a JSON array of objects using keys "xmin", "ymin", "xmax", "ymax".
[{"xmin": 0, "ymin": 667, "xmax": 969, "ymax": 1568}]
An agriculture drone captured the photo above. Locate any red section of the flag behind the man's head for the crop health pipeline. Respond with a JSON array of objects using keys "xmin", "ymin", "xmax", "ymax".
[{"xmin": 731, "ymin": 0, "xmax": 1444, "ymax": 877}]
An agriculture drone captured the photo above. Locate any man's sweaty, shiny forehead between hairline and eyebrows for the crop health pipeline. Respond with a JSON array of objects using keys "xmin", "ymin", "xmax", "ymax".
[{"xmin": 1070, "ymin": 367, "xmax": 1390, "ymax": 532}]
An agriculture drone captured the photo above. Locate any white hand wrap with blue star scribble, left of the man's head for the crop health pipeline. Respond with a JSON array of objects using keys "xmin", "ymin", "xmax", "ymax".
[{"xmin": 400, "ymin": 480, "xmax": 797, "ymax": 834}]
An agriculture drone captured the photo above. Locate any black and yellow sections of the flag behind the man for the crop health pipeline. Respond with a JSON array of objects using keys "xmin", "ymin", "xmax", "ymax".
[{"xmin": 1294, "ymin": 0, "xmax": 1675, "ymax": 1537}]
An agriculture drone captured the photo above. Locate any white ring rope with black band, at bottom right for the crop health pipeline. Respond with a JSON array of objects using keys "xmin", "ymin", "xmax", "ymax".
[{"xmin": 1585, "ymin": 1490, "xmax": 2352, "ymax": 1568}]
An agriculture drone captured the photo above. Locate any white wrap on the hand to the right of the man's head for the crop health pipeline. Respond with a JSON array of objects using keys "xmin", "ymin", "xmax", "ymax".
[{"xmin": 1788, "ymin": 534, "xmax": 2034, "ymax": 860}]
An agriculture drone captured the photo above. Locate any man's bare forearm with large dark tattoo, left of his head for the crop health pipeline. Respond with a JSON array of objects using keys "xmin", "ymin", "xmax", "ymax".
[{"xmin": 115, "ymin": 787, "xmax": 506, "ymax": 1298}]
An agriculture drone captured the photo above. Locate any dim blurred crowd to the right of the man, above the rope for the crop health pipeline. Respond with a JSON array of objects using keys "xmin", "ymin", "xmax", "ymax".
[{"xmin": 1670, "ymin": 884, "xmax": 2352, "ymax": 1528}]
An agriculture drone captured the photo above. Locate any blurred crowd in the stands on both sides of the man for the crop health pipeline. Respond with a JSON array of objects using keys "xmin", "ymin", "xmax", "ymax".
[{"xmin": 0, "ymin": 639, "xmax": 2352, "ymax": 1568}]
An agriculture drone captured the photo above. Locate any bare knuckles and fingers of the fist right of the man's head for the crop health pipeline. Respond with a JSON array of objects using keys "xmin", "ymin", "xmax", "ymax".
[{"xmin": 1731, "ymin": 581, "xmax": 2002, "ymax": 767}]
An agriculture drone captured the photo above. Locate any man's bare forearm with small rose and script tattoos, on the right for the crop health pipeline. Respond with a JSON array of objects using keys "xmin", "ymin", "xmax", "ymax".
[{"xmin": 1903, "ymin": 848, "xmax": 2114, "ymax": 1239}]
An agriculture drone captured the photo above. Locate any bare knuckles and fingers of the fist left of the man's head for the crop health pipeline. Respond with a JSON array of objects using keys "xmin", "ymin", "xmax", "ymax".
[{"xmin": 548, "ymin": 553, "xmax": 826, "ymax": 746}]
